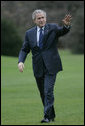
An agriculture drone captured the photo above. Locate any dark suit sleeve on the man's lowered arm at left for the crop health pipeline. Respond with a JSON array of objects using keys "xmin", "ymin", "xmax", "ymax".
[{"xmin": 18, "ymin": 32, "xmax": 30, "ymax": 63}]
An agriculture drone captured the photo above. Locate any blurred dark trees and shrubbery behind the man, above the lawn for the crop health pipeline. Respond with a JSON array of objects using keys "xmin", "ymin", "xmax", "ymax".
[{"xmin": 1, "ymin": 1, "xmax": 84, "ymax": 57}]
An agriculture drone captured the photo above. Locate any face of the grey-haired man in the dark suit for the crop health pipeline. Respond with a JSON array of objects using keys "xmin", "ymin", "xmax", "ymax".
[{"xmin": 34, "ymin": 13, "xmax": 46, "ymax": 27}]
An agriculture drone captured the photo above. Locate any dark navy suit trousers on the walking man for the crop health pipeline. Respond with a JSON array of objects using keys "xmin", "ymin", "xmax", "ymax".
[{"xmin": 35, "ymin": 63, "xmax": 56, "ymax": 119}]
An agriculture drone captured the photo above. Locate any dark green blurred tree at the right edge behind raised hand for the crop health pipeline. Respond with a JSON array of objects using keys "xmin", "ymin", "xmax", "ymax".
[{"xmin": 69, "ymin": 8, "xmax": 84, "ymax": 54}]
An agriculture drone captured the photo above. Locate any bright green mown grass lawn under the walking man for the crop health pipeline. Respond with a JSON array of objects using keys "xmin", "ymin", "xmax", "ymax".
[{"xmin": 1, "ymin": 51, "xmax": 84, "ymax": 125}]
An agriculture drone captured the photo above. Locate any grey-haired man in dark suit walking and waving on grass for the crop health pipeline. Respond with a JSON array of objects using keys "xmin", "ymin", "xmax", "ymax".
[{"xmin": 18, "ymin": 10, "xmax": 71, "ymax": 123}]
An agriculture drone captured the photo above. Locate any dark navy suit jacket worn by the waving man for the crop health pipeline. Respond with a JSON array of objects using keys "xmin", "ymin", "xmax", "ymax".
[{"xmin": 19, "ymin": 24, "xmax": 70, "ymax": 77}]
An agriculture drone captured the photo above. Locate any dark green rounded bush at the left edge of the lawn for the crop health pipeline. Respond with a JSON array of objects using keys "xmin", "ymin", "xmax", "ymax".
[{"xmin": 1, "ymin": 19, "xmax": 22, "ymax": 56}]
